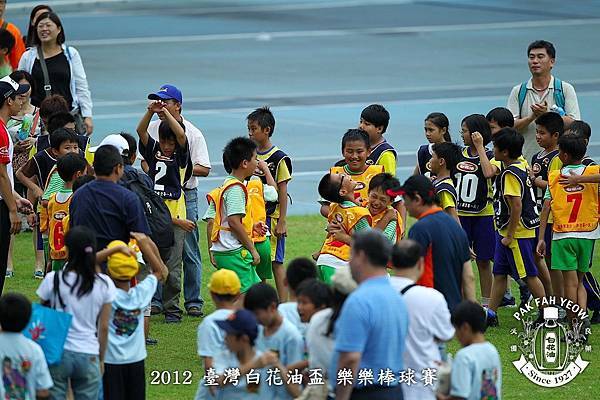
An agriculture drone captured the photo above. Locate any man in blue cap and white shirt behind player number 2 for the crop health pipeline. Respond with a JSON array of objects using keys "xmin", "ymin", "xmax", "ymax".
[{"xmin": 142, "ymin": 85, "xmax": 210, "ymax": 317}]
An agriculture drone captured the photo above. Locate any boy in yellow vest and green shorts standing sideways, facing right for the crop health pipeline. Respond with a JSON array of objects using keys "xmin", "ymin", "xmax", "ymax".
[{"xmin": 203, "ymin": 137, "xmax": 260, "ymax": 293}]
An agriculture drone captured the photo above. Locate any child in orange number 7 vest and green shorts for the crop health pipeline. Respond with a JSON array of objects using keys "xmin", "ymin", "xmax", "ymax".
[{"xmin": 537, "ymin": 134, "xmax": 600, "ymax": 324}]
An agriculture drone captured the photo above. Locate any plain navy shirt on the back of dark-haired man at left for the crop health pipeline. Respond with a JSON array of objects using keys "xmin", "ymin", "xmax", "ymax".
[{"xmin": 69, "ymin": 179, "xmax": 150, "ymax": 250}]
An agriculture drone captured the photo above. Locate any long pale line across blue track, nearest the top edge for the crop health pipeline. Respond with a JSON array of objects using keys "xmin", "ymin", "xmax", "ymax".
[{"xmin": 69, "ymin": 18, "xmax": 600, "ymax": 47}]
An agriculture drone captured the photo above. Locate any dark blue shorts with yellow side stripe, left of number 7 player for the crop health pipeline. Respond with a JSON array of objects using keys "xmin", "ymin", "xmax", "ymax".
[{"xmin": 492, "ymin": 233, "xmax": 538, "ymax": 280}]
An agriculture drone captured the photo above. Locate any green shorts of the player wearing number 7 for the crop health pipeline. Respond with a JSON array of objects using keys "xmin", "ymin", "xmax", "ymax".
[{"xmin": 552, "ymin": 238, "xmax": 594, "ymax": 272}]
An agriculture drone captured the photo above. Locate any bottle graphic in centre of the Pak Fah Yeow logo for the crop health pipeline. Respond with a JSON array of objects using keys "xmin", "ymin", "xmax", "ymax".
[{"xmin": 534, "ymin": 307, "xmax": 568, "ymax": 371}]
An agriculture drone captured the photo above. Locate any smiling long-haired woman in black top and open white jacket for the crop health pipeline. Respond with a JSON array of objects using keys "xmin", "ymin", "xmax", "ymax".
[{"xmin": 19, "ymin": 12, "xmax": 94, "ymax": 135}]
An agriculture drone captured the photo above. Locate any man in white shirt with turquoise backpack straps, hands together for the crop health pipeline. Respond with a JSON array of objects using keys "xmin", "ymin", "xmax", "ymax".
[{"xmin": 506, "ymin": 40, "xmax": 581, "ymax": 160}]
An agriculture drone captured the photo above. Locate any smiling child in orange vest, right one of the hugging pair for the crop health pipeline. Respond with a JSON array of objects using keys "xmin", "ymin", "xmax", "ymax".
[{"xmin": 367, "ymin": 173, "xmax": 404, "ymax": 243}]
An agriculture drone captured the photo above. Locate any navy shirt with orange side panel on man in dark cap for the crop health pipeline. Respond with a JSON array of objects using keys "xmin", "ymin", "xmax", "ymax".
[{"xmin": 408, "ymin": 208, "xmax": 471, "ymax": 311}]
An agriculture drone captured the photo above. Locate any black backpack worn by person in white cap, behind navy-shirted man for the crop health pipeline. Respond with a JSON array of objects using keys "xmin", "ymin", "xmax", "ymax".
[{"xmin": 121, "ymin": 171, "xmax": 175, "ymax": 249}]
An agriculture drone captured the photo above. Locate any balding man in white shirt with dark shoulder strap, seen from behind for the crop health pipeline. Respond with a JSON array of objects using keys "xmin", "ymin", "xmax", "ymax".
[{"xmin": 391, "ymin": 239, "xmax": 454, "ymax": 400}]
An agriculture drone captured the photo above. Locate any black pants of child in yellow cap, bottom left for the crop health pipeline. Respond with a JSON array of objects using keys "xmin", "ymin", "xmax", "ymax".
[{"xmin": 102, "ymin": 360, "xmax": 146, "ymax": 400}]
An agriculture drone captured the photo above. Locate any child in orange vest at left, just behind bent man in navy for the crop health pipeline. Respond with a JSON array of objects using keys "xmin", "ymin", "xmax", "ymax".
[{"xmin": 40, "ymin": 153, "xmax": 87, "ymax": 271}]
